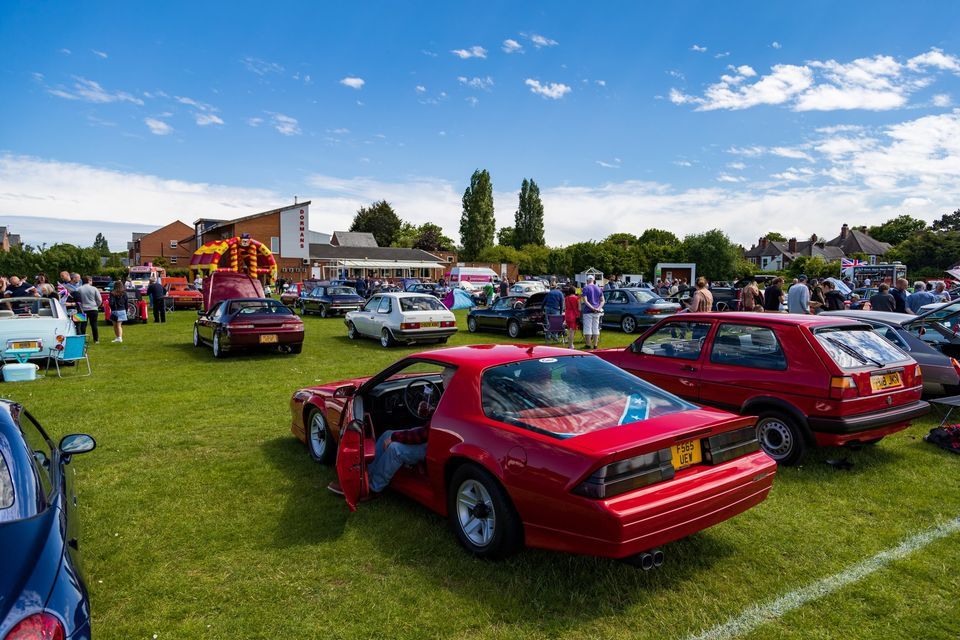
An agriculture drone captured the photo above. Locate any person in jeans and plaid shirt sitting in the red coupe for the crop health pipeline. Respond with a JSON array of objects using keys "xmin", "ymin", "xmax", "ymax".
[{"xmin": 327, "ymin": 367, "xmax": 456, "ymax": 496}]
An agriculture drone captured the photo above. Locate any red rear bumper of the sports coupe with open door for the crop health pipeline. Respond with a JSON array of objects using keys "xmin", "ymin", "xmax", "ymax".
[{"xmin": 524, "ymin": 451, "xmax": 777, "ymax": 558}]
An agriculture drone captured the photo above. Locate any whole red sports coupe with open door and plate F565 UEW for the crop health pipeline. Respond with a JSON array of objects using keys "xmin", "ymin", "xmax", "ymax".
[{"xmin": 290, "ymin": 345, "xmax": 776, "ymax": 568}]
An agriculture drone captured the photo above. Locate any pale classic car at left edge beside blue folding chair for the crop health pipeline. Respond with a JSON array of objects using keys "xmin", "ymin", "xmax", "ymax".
[{"xmin": 0, "ymin": 298, "xmax": 77, "ymax": 360}]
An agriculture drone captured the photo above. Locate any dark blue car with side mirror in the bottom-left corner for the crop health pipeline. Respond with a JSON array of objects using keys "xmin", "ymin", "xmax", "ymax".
[{"xmin": 0, "ymin": 400, "xmax": 96, "ymax": 640}]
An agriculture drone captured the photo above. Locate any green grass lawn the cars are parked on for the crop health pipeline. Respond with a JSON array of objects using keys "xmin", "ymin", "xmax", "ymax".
[{"xmin": 0, "ymin": 311, "xmax": 960, "ymax": 640}]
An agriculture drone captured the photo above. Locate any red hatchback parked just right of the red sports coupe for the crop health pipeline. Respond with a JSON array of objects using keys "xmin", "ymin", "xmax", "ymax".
[{"xmin": 595, "ymin": 313, "xmax": 930, "ymax": 464}]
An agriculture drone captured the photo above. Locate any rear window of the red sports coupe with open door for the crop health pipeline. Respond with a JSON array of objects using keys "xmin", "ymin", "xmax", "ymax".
[{"xmin": 480, "ymin": 356, "xmax": 696, "ymax": 438}]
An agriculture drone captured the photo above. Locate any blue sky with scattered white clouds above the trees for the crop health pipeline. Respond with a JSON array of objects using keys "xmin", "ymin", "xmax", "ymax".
[{"xmin": 0, "ymin": 1, "xmax": 960, "ymax": 246}]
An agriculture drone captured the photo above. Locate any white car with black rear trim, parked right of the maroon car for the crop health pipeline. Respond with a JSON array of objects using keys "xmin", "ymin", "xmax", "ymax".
[{"xmin": 343, "ymin": 292, "xmax": 457, "ymax": 347}]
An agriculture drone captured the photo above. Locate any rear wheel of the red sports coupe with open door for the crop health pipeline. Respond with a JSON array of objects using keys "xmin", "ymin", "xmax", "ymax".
[{"xmin": 447, "ymin": 463, "xmax": 523, "ymax": 559}]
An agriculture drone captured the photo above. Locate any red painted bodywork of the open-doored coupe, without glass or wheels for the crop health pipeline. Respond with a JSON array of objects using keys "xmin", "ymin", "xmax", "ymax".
[{"xmin": 290, "ymin": 345, "xmax": 776, "ymax": 558}]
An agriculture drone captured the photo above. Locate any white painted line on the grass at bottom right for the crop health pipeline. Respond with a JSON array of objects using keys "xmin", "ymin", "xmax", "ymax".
[{"xmin": 689, "ymin": 517, "xmax": 960, "ymax": 640}]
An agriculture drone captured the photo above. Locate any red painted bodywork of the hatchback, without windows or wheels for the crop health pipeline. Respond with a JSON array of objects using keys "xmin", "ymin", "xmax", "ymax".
[{"xmin": 595, "ymin": 313, "xmax": 928, "ymax": 445}]
